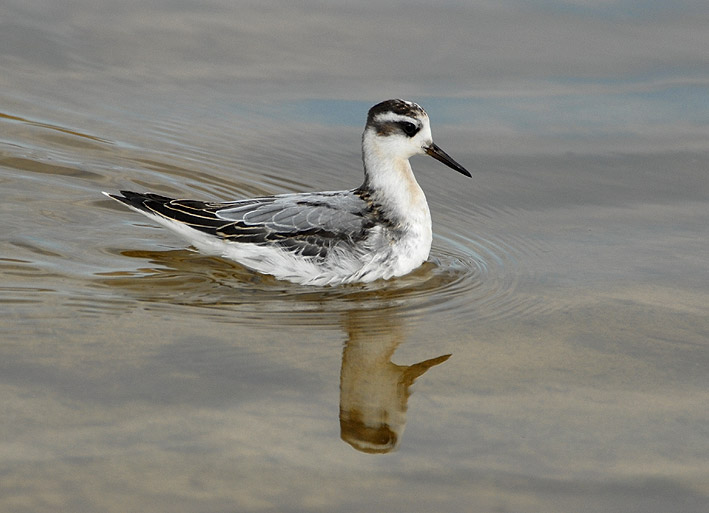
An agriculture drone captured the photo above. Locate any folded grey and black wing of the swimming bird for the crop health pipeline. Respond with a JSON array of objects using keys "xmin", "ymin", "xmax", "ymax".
[{"xmin": 111, "ymin": 191, "xmax": 374, "ymax": 258}]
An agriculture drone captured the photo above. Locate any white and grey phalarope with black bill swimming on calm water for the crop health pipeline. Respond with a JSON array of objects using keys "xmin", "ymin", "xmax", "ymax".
[{"xmin": 104, "ymin": 100, "xmax": 471, "ymax": 285}]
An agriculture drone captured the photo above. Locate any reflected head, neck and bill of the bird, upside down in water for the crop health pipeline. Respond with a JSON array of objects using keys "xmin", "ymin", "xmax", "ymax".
[{"xmin": 340, "ymin": 310, "xmax": 450, "ymax": 453}]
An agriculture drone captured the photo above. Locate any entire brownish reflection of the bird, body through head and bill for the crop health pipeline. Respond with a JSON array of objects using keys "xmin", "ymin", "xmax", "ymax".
[{"xmin": 96, "ymin": 250, "xmax": 450, "ymax": 453}]
